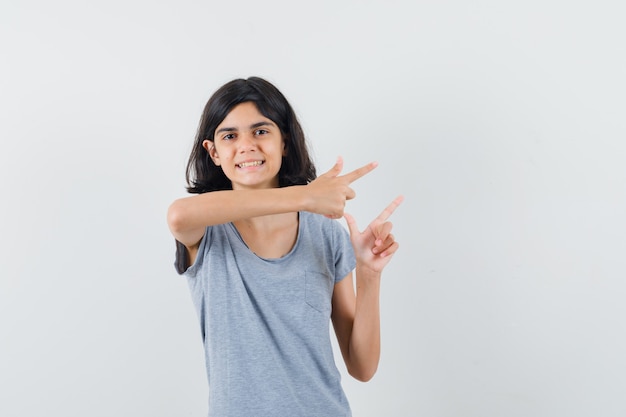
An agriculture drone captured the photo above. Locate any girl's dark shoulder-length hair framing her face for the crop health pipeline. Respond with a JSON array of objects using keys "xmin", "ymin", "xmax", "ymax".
[{"xmin": 186, "ymin": 77, "xmax": 316, "ymax": 194}]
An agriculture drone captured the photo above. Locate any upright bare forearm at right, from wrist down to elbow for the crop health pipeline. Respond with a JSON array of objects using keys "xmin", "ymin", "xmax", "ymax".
[{"xmin": 349, "ymin": 264, "xmax": 381, "ymax": 381}]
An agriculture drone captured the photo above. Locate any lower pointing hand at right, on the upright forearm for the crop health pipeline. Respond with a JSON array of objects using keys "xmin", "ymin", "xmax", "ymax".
[{"xmin": 344, "ymin": 196, "xmax": 404, "ymax": 272}]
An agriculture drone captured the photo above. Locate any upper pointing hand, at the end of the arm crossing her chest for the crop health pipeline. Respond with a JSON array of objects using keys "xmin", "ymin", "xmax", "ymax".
[{"xmin": 306, "ymin": 157, "xmax": 378, "ymax": 219}]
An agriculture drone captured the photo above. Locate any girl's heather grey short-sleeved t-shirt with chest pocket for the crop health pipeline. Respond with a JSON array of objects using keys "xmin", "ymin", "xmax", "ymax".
[{"xmin": 183, "ymin": 212, "xmax": 356, "ymax": 417}]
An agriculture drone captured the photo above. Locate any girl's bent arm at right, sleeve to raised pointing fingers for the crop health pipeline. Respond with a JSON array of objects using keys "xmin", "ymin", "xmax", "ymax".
[{"xmin": 331, "ymin": 196, "xmax": 403, "ymax": 381}]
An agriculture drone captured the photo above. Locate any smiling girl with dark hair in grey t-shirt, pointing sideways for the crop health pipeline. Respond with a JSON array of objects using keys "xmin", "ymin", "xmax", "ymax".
[{"xmin": 167, "ymin": 77, "xmax": 402, "ymax": 417}]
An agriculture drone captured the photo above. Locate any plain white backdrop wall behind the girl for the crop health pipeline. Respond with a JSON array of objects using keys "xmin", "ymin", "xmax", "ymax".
[{"xmin": 0, "ymin": 0, "xmax": 626, "ymax": 417}]
